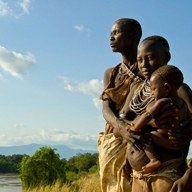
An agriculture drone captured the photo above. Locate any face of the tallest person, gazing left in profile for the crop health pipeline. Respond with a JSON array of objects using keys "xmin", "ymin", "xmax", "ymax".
[{"xmin": 110, "ymin": 23, "xmax": 131, "ymax": 53}]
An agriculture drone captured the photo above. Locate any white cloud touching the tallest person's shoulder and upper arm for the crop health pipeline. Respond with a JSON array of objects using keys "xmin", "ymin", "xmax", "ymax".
[{"xmin": 60, "ymin": 77, "xmax": 103, "ymax": 109}]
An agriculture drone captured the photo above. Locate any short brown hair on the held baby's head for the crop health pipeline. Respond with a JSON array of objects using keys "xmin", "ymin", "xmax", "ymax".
[{"xmin": 151, "ymin": 65, "xmax": 184, "ymax": 89}]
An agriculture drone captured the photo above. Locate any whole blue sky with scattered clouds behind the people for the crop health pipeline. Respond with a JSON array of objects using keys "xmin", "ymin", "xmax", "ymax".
[{"xmin": 0, "ymin": 0, "xmax": 192, "ymax": 155}]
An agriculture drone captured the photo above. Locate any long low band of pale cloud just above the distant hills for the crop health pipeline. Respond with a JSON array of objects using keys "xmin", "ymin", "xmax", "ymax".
[{"xmin": 0, "ymin": 129, "xmax": 98, "ymax": 150}]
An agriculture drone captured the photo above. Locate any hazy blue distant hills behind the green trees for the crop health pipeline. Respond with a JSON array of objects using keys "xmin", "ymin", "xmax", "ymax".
[{"xmin": 0, "ymin": 144, "xmax": 97, "ymax": 159}]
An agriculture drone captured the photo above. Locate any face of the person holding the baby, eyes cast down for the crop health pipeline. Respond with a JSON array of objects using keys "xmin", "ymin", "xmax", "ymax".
[{"xmin": 137, "ymin": 40, "xmax": 167, "ymax": 79}]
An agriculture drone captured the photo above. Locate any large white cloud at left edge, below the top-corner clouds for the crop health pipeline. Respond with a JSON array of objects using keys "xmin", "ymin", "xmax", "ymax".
[{"xmin": 0, "ymin": 46, "xmax": 35, "ymax": 79}]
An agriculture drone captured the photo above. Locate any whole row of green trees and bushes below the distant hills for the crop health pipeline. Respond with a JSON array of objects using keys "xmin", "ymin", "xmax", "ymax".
[{"xmin": 0, "ymin": 147, "xmax": 98, "ymax": 189}]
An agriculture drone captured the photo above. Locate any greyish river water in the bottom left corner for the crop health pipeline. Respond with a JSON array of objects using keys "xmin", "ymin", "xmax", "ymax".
[{"xmin": 0, "ymin": 174, "xmax": 22, "ymax": 192}]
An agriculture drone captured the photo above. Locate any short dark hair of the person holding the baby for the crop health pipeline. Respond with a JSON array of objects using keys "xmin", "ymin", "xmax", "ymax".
[{"xmin": 141, "ymin": 35, "xmax": 171, "ymax": 63}]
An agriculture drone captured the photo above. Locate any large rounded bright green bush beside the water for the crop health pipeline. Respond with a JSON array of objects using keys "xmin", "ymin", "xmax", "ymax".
[{"xmin": 20, "ymin": 147, "xmax": 66, "ymax": 188}]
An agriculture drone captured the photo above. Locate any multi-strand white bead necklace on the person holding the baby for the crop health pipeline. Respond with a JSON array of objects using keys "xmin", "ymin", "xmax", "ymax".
[{"xmin": 129, "ymin": 80, "xmax": 153, "ymax": 115}]
